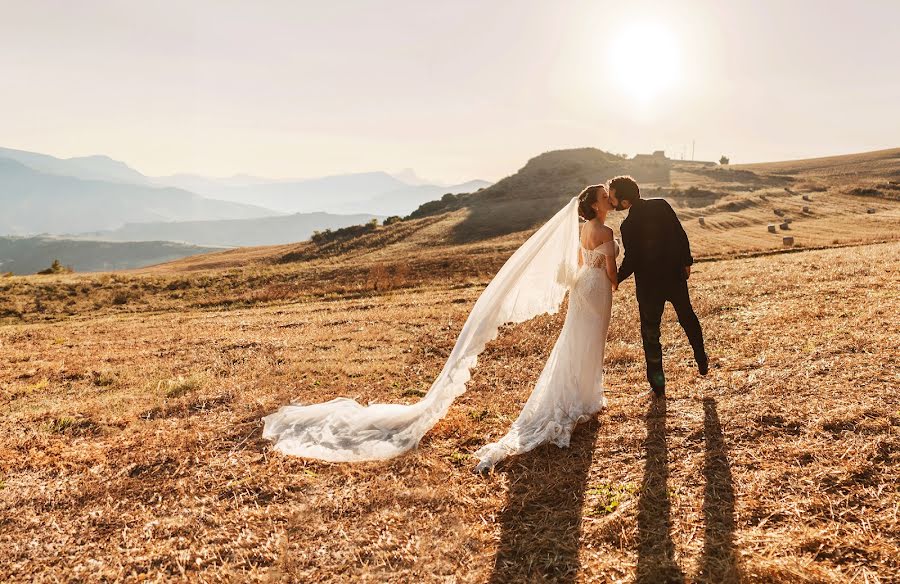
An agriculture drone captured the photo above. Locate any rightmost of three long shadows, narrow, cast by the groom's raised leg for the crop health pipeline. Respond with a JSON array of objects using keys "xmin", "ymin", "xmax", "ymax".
[{"xmin": 697, "ymin": 398, "xmax": 741, "ymax": 583}]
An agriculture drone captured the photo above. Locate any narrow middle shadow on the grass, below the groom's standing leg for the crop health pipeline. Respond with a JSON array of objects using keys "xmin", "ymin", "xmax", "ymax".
[{"xmin": 636, "ymin": 398, "xmax": 684, "ymax": 584}]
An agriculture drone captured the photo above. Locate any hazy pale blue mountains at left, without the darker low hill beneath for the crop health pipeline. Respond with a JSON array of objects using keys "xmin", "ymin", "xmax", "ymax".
[{"xmin": 0, "ymin": 148, "xmax": 490, "ymax": 235}]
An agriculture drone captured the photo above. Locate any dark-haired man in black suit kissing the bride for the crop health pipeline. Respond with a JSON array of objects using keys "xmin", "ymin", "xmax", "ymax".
[{"xmin": 608, "ymin": 176, "xmax": 709, "ymax": 396}]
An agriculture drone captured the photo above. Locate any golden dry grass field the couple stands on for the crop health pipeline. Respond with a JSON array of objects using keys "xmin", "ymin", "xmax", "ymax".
[{"xmin": 0, "ymin": 151, "xmax": 900, "ymax": 583}]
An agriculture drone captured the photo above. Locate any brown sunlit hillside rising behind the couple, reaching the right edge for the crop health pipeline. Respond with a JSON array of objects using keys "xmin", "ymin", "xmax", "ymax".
[{"xmin": 144, "ymin": 148, "xmax": 900, "ymax": 272}]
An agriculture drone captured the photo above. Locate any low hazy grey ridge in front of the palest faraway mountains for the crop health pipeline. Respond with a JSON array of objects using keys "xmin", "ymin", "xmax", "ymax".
[{"xmin": 77, "ymin": 213, "xmax": 383, "ymax": 247}]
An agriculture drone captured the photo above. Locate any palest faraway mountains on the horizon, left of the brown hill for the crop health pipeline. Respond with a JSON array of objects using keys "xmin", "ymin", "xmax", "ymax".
[{"xmin": 154, "ymin": 172, "xmax": 490, "ymax": 215}]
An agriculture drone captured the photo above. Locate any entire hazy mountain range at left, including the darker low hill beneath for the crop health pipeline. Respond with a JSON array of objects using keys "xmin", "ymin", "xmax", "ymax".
[{"xmin": 0, "ymin": 148, "xmax": 489, "ymax": 273}]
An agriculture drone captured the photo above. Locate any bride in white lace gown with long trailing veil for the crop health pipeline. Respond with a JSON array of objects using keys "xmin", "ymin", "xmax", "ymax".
[{"xmin": 263, "ymin": 185, "xmax": 619, "ymax": 471}]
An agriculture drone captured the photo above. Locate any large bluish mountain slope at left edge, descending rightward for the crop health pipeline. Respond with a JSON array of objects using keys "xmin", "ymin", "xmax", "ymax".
[{"xmin": 0, "ymin": 158, "xmax": 277, "ymax": 235}]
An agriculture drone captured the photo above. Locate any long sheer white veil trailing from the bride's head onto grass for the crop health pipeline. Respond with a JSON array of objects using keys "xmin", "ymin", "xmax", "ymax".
[{"xmin": 263, "ymin": 197, "xmax": 578, "ymax": 462}]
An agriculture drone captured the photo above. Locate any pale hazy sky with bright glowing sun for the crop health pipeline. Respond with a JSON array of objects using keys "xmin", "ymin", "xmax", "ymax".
[{"xmin": 0, "ymin": 0, "xmax": 900, "ymax": 181}]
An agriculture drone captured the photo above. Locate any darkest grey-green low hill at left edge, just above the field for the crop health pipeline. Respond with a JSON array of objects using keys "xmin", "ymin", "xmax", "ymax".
[{"xmin": 0, "ymin": 237, "xmax": 220, "ymax": 274}]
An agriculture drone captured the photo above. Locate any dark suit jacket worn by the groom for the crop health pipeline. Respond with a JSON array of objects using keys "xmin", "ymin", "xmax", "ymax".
[{"xmin": 618, "ymin": 199, "xmax": 694, "ymax": 288}]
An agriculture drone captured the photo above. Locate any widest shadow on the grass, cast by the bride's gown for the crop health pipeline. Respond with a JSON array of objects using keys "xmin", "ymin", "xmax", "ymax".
[{"xmin": 489, "ymin": 417, "xmax": 600, "ymax": 583}]
